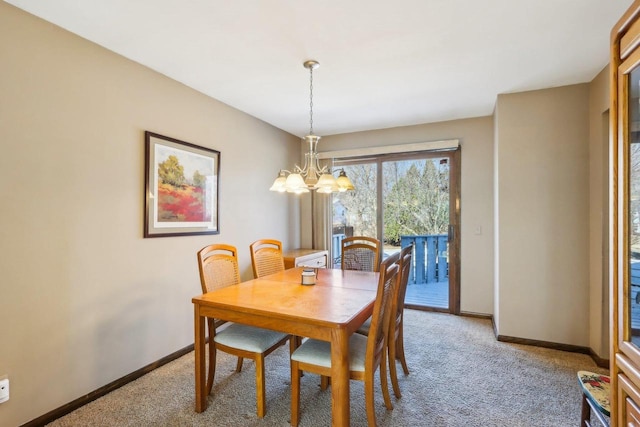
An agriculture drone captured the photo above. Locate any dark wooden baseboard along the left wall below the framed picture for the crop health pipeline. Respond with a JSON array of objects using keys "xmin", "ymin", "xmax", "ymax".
[{"xmin": 21, "ymin": 344, "xmax": 193, "ymax": 427}]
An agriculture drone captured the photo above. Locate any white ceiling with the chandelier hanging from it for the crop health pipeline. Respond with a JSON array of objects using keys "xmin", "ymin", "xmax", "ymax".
[{"xmin": 5, "ymin": 0, "xmax": 632, "ymax": 136}]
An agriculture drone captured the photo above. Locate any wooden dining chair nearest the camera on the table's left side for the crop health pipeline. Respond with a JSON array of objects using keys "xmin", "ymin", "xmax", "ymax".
[{"xmin": 198, "ymin": 244, "xmax": 293, "ymax": 418}]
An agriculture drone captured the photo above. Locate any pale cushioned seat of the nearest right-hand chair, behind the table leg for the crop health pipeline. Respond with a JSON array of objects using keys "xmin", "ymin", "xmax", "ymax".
[{"xmin": 291, "ymin": 334, "xmax": 367, "ymax": 372}]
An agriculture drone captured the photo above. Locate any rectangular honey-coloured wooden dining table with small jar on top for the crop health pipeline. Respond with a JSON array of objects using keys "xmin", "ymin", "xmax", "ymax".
[{"xmin": 192, "ymin": 268, "xmax": 379, "ymax": 426}]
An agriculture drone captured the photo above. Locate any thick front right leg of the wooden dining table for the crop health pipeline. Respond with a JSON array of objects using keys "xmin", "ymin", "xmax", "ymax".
[{"xmin": 331, "ymin": 329, "xmax": 351, "ymax": 427}]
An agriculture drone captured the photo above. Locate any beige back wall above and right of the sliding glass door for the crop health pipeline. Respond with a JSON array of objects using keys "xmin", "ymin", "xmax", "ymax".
[{"xmin": 320, "ymin": 117, "xmax": 494, "ymax": 314}]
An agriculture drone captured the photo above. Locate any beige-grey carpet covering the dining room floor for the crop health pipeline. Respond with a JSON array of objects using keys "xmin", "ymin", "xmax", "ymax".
[{"xmin": 49, "ymin": 310, "xmax": 607, "ymax": 427}]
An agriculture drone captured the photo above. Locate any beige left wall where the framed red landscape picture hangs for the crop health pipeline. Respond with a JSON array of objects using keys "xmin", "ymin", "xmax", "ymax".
[{"xmin": 0, "ymin": 2, "xmax": 300, "ymax": 426}]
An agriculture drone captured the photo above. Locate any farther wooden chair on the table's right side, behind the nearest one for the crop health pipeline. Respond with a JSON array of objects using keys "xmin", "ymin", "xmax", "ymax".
[{"xmin": 357, "ymin": 245, "xmax": 413, "ymax": 399}]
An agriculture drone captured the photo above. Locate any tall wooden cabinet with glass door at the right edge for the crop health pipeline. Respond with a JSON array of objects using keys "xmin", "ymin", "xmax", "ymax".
[{"xmin": 610, "ymin": 0, "xmax": 640, "ymax": 427}]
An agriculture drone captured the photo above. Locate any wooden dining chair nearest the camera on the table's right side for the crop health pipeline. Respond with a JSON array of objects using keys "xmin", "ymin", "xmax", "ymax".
[{"xmin": 291, "ymin": 254, "xmax": 399, "ymax": 427}]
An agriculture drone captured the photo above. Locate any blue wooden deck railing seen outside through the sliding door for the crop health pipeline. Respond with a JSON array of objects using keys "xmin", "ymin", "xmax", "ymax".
[{"xmin": 331, "ymin": 234, "xmax": 449, "ymax": 283}]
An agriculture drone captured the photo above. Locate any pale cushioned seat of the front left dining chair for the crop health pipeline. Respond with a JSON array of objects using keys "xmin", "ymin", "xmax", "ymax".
[{"xmin": 213, "ymin": 323, "xmax": 287, "ymax": 353}]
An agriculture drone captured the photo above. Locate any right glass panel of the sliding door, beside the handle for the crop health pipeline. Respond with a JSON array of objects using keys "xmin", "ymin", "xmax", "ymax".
[{"xmin": 382, "ymin": 157, "xmax": 450, "ymax": 309}]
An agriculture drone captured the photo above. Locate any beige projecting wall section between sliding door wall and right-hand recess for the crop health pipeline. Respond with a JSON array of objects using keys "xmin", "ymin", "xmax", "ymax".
[{"xmin": 495, "ymin": 84, "xmax": 589, "ymax": 346}]
